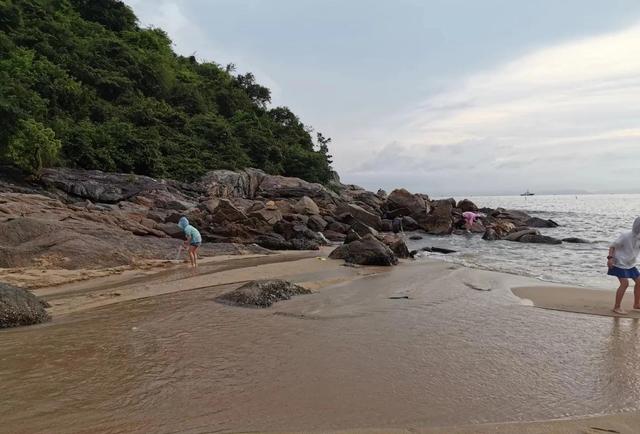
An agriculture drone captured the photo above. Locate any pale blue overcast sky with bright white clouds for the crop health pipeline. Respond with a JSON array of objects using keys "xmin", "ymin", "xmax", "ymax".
[{"xmin": 126, "ymin": 0, "xmax": 640, "ymax": 195}]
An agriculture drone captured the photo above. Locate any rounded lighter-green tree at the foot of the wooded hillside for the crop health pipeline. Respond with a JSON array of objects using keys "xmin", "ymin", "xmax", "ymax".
[{"xmin": 6, "ymin": 119, "xmax": 62, "ymax": 174}]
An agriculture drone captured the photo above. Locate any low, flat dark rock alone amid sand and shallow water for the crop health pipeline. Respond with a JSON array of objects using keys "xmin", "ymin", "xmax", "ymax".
[{"xmin": 216, "ymin": 280, "xmax": 311, "ymax": 307}]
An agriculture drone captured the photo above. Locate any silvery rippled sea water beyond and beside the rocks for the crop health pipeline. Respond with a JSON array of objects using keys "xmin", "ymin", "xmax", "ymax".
[{"xmin": 408, "ymin": 194, "xmax": 640, "ymax": 288}]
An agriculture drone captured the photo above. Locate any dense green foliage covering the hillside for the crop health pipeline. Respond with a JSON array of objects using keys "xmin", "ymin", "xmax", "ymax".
[{"xmin": 0, "ymin": 0, "xmax": 331, "ymax": 182}]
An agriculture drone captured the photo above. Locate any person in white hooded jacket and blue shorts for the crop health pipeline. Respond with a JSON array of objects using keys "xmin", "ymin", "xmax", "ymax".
[{"xmin": 607, "ymin": 217, "xmax": 640, "ymax": 315}]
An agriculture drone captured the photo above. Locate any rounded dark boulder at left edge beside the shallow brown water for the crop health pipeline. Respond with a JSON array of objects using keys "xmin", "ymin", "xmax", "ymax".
[{"xmin": 0, "ymin": 283, "xmax": 50, "ymax": 328}]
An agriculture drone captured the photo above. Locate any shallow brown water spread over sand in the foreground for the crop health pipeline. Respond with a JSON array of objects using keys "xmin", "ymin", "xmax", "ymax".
[{"xmin": 0, "ymin": 263, "xmax": 640, "ymax": 433}]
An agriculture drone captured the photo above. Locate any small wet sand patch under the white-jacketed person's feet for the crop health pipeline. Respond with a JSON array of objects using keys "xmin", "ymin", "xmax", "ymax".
[{"xmin": 513, "ymin": 286, "xmax": 640, "ymax": 319}]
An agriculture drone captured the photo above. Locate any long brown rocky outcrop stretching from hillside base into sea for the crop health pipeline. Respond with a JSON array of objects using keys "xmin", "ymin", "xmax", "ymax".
[{"xmin": 0, "ymin": 165, "xmax": 557, "ymax": 268}]
